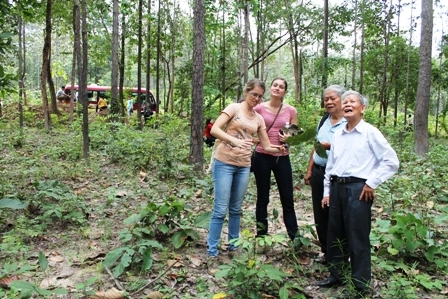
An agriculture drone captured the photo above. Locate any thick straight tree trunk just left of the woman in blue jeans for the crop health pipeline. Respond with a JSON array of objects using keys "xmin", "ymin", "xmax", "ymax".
[{"xmin": 190, "ymin": 0, "xmax": 205, "ymax": 172}]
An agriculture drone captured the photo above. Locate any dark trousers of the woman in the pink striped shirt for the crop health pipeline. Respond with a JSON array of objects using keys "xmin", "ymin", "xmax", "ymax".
[{"xmin": 252, "ymin": 152, "xmax": 298, "ymax": 240}]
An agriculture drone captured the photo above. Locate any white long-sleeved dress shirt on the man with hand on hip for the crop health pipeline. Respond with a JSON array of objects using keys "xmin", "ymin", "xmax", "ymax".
[{"xmin": 324, "ymin": 119, "xmax": 399, "ymax": 196}]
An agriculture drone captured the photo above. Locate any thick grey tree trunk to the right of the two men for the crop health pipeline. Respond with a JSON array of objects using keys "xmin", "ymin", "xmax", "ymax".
[{"xmin": 414, "ymin": 0, "xmax": 433, "ymax": 156}]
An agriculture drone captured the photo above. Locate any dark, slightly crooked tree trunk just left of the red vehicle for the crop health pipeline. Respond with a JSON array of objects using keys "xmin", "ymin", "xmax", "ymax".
[{"xmin": 40, "ymin": 0, "xmax": 52, "ymax": 130}]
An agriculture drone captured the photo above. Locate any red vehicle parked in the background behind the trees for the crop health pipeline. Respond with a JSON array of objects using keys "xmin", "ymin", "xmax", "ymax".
[{"xmin": 64, "ymin": 85, "xmax": 158, "ymax": 112}]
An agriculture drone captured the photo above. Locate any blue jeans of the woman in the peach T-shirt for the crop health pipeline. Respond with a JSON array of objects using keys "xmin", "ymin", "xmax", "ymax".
[{"xmin": 207, "ymin": 159, "xmax": 250, "ymax": 256}]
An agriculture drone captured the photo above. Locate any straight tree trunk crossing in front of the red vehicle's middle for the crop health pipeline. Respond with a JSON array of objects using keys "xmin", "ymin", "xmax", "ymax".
[{"xmin": 110, "ymin": 0, "xmax": 120, "ymax": 121}]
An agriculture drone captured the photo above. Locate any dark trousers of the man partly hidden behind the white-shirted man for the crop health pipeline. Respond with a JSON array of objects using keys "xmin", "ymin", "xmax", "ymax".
[{"xmin": 310, "ymin": 164, "xmax": 328, "ymax": 255}]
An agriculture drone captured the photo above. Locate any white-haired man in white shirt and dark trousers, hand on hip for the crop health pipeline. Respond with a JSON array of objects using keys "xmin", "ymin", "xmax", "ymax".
[{"xmin": 316, "ymin": 90, "xmax": 399, "ymax": 296}]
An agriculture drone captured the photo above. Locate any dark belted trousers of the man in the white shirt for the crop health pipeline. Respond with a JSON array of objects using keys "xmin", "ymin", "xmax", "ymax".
[{"xmin": 327, "ymin": 182, "xmax": 372, "ymax": 290}]
